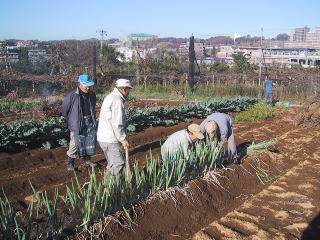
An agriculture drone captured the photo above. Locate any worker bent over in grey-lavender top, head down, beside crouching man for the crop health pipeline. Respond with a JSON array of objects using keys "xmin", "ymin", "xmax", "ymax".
[{"xmin": 200, "ymin": 112, "xmax": 240, "ymax": 164}]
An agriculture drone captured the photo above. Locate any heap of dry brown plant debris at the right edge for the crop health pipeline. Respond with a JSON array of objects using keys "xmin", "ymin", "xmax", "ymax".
[{"xmin": 296, "ymin": 95, "xmax": 320, "ymax": 127}]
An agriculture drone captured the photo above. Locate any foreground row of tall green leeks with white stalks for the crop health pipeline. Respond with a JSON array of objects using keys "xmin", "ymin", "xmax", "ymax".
[{"xmin": 0, "ymin": 139, "xmax": 221, "ymax": 239}]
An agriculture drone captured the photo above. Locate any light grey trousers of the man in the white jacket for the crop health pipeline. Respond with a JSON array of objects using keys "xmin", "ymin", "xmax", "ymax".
[{"xmin": 99, "ymin": 142, "xmax": 125, "ymax": 175}]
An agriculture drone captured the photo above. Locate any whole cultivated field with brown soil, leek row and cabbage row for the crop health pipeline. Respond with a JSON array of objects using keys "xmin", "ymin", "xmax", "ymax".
[{"xmin": 0, "ymin": 99, "xmax": 320, "ymax": 240}]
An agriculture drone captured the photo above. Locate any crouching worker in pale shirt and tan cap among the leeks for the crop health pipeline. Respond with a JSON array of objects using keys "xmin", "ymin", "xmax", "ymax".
[{"xmin": 161, "ymin": 123, "xmax": 204, "ymax": 161}]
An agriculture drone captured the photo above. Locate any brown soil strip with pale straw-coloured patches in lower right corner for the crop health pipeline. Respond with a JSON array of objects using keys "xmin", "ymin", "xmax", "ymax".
[{"xmin": 190, "ymin": 155, "xmax": 320, "ymax": 240}]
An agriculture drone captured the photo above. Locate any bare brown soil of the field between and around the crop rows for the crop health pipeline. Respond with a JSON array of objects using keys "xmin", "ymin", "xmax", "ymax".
[{"xmin": 0, "ymin": 108, "xmax": 320, "ymax": 240}]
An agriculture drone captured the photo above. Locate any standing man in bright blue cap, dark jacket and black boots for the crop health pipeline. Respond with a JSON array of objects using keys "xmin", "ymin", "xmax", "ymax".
[{"xmin": 62, "ymin": 75, "xmax": 97, "ymax": 171}]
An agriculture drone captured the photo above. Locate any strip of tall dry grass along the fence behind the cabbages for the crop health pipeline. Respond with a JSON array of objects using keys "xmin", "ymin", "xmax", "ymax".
[{"xmin": 130, "ymin": 83, "xmax": 319, "ymax": 103}]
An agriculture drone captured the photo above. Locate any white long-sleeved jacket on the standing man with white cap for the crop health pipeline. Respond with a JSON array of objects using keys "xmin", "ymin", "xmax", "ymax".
[{"xmin": 97, "ymin": 88, "xmax": 127, "ymax": 143}]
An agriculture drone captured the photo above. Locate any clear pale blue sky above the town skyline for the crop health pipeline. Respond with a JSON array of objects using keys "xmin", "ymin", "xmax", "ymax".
[{"xmin": 0, "ymin": 0, "xmax": 320, "ymax": 41}]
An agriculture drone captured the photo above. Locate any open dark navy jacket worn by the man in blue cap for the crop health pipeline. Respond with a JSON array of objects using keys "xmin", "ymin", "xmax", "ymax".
[{"xmin": 62, "ymin": 88, "xmax": 97, "ymax": 134}]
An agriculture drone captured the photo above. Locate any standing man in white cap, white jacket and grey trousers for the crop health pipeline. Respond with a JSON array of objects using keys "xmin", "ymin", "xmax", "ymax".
[{"xmin": 97, "ymin": 79, "xmax": 132, "ymax": 175}]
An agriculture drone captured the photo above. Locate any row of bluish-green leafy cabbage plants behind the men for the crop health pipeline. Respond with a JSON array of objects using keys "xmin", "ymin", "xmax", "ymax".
[{"xmin": 0, "ymin": 97, "xmax": 258, "ymax": 152}]
